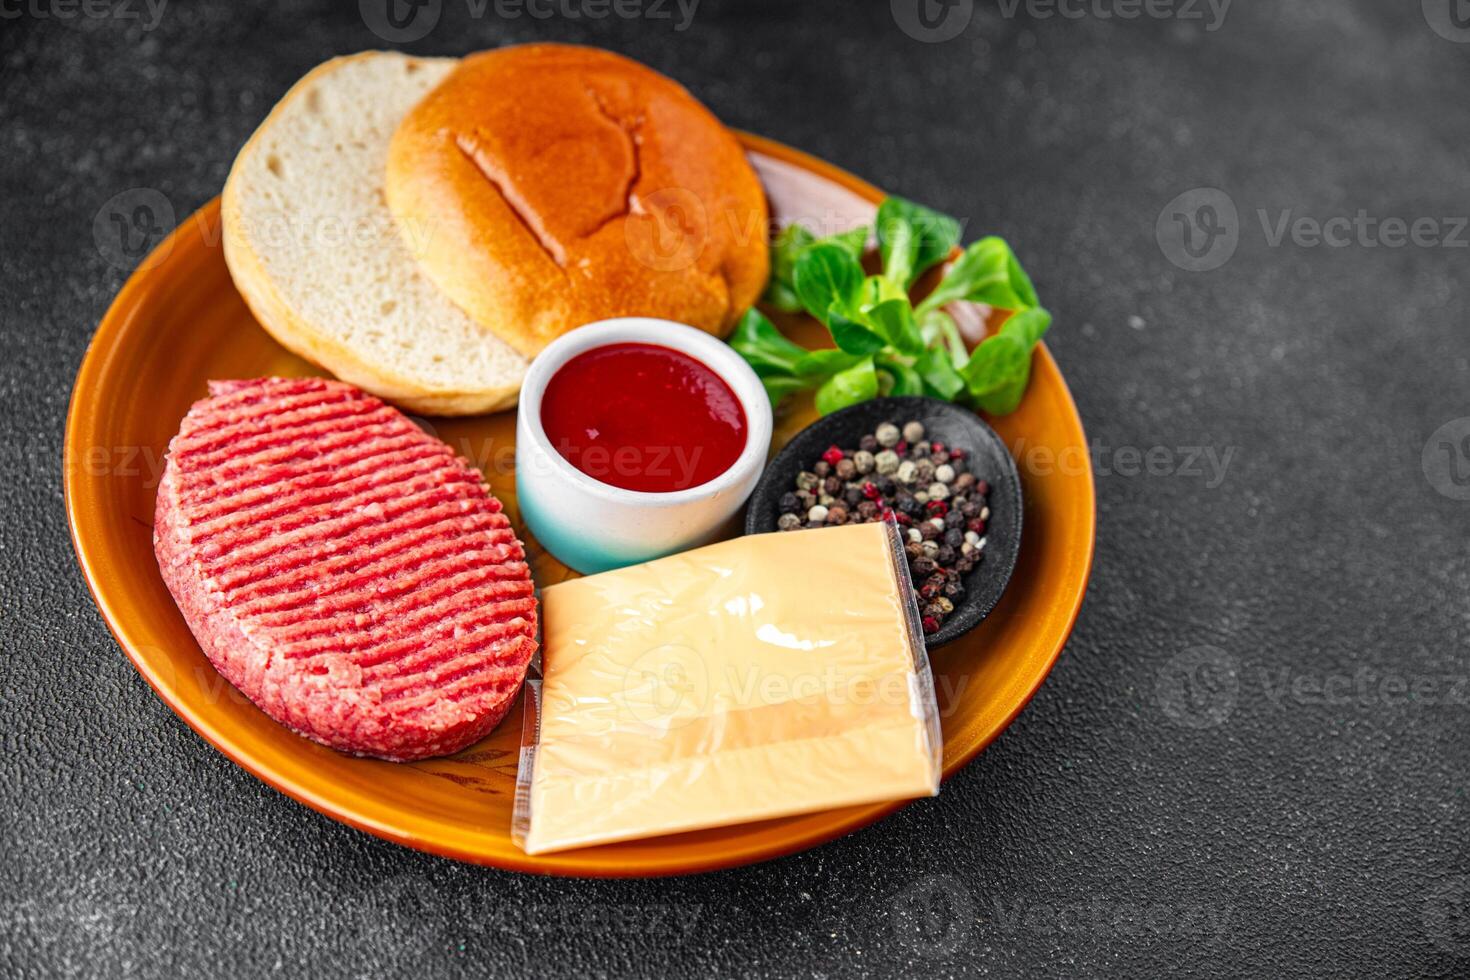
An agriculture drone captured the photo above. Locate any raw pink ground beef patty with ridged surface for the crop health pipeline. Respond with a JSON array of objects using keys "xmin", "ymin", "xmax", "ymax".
[{"xmin": 153, "ymin": 378, "xmax": 537, "ymax": 761}]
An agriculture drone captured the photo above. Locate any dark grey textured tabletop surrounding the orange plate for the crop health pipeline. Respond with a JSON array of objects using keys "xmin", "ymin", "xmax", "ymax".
[{"xmin": 0, "ymin": 0, "xmax": 1470, "ymax": 977}]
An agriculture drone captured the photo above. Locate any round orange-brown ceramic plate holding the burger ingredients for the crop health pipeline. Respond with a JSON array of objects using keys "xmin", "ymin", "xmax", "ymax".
[{"xmin": 65, "ymin": 137, "xmax": 1094, "ymax": 876}]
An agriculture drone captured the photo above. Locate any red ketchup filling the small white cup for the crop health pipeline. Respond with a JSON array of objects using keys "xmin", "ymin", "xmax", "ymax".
[{"xmin": 541, "ymin": 344, "xmax": 747, "ymax": 494}]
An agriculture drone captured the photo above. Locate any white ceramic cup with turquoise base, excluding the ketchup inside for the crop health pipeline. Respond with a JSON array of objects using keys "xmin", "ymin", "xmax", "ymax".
[{"xmin": 516, "ymin": 317, "xmax": 772, "ymax": 573}]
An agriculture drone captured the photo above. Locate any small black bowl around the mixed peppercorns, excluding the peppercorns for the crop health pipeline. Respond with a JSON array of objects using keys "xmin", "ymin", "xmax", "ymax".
[{"xmin": 745, "ymin": 397, "xmax": 1022, "ymax": 649}]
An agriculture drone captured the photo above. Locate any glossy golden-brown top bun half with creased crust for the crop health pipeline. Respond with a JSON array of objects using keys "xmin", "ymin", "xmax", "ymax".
[{"xmin": 387, "ymin": 44, "xmax": 767, "ymax": 356}]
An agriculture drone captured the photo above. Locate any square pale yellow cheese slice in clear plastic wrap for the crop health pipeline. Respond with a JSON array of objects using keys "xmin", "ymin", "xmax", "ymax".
[{"xmin": 515, "ymin": 523, "xmax": 941, "ymax": 854}]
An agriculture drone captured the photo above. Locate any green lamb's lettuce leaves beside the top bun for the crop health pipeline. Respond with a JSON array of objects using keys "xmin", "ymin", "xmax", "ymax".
[{"xmin": 731, "ymin": 197, "xmax": 1051, "ymax": 414}]
